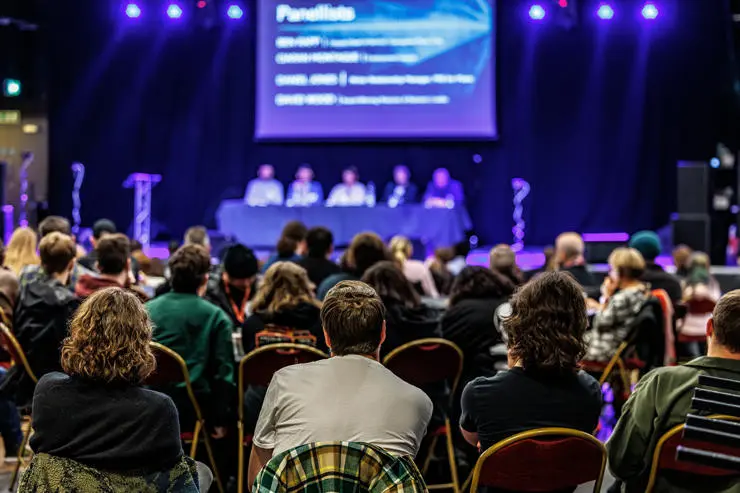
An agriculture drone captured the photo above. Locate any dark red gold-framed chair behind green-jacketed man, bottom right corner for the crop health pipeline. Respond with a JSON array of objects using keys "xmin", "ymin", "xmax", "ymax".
[{"xmin": 645, "ymin": 414, "xmax": 740, "ymax": 493}]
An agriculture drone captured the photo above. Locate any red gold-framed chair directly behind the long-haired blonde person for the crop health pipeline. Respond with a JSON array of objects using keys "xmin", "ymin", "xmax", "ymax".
[{"xmin": 237, "ymin": 343, "xmax": 328, "ymax": 493}]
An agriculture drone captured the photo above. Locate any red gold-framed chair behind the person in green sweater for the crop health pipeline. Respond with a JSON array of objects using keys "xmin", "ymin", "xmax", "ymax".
[{"xmin": 144, "ymin": 342, "xmax": 224, "ymax": 493}]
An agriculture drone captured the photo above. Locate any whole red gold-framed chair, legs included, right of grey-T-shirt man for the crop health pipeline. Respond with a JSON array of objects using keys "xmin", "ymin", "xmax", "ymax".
[{"xmin": 383, "ymin": 338, "xmax": 463, "ymax": 493}]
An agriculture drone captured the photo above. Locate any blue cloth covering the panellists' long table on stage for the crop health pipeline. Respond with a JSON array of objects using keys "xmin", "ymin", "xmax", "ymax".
[{"xmin": 216, "ymin": 200, "xmax": 471, "ymax": 248}]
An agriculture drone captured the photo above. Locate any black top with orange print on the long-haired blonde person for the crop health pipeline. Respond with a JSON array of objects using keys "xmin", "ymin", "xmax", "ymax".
[{"xmin": 242, "ymin": 303, "xmax": 328, "ymax": 353}]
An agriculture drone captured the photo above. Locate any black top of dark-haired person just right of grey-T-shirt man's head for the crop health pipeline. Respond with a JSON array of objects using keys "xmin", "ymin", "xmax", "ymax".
[{"xmin": 380, "ymin": 300, "xmax": 442, "ymax": 360}]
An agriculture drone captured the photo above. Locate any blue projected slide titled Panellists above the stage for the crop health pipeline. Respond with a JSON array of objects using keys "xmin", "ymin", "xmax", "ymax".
[{"xmin": 255, "ymin": 0, "xmax": 497, "ymax": 140}]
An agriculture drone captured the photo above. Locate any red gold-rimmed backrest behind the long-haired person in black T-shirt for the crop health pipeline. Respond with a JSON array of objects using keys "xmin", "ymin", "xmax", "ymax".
[{"xmin": 470, "ymin": 428, "xmax": 606, "ymax": 492}]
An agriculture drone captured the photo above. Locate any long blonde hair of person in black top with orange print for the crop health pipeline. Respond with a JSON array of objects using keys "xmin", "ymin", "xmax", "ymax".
[{"xmin": 252, "ymin": 262, "xmax": 321, "ymax": 313}]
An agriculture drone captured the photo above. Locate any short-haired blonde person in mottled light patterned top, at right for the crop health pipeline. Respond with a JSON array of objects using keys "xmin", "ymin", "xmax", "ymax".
[{"xmin": 586, "ymin": 248, "xmax": 650, "ymax": 362}]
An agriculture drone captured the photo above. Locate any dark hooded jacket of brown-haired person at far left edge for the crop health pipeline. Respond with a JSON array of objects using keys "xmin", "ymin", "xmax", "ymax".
[{"xmin": 0, "ymin": 276, "xmax": 80, "ymax": 406}]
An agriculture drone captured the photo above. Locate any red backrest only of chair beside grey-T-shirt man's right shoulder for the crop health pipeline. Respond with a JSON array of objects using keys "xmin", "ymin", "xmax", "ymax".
[{"xmin": 383, "ymin": 338, "xmax": 463, "ymax": 395}]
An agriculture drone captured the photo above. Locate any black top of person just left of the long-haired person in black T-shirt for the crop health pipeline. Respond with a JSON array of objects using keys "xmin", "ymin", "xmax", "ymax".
[{"xmin": 441, "ymin": 298, "xmax": 507, "ymax": 380}]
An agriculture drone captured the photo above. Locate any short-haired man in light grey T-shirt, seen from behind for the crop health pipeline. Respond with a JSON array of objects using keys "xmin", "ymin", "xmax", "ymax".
[{"xmin": 247, "ymin": 281, "xmax": 432, "ymax": 484}]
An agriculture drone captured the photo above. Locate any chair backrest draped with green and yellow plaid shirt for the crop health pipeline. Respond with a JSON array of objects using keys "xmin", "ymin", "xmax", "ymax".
[{"xmin": 252, "ymin": 442, "xmax": 427, "ymax": 493}]
